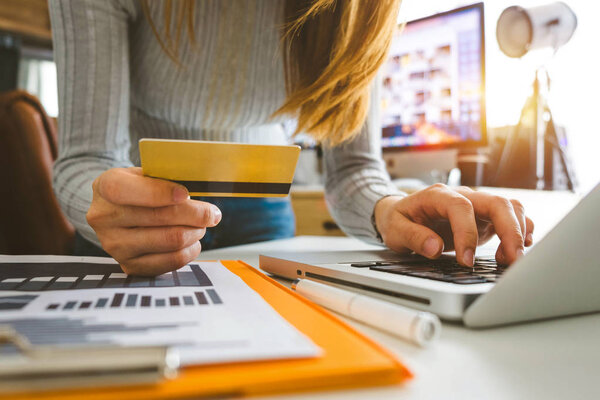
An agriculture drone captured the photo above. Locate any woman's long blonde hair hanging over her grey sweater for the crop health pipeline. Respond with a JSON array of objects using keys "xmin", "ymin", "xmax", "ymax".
[{"xmin": 141, "ymin": 0, "xmax": 401, "ymax": 145}]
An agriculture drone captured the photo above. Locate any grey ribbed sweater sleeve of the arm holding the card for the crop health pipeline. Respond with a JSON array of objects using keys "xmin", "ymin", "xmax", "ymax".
[{"xmin": 49, "ymin": 0, "xmax": 136, "ymax": 245}]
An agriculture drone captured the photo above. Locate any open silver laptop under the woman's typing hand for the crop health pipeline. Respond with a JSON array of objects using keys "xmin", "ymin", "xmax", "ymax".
[{"xmin": 260, "ymin": 185, "xmax": 600, "ymax": 327}]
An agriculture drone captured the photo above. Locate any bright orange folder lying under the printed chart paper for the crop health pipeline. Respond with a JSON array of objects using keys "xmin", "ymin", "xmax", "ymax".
[{"xmin": 4, "ymin": 261, "xmax": 412, "ymax": 400}]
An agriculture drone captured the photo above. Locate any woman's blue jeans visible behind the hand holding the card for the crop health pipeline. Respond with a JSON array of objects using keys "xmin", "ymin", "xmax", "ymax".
[{"xmin": 73, "ymin": 197, "xmax": 296, "ymax": 257}]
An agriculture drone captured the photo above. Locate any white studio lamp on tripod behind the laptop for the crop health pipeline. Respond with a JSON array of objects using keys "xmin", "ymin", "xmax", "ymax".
[{"xmin": 495, "ymin": 2, "xmax": 577, "ymax": 190}]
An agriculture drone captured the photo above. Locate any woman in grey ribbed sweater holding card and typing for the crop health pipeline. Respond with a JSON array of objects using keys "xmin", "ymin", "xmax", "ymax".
[{"xmin": 50, "ymin": 0, "xmax": 533, "ymax": 275}]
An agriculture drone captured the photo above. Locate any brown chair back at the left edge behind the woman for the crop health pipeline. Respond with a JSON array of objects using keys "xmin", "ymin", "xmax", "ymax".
[{"xmin": 0, "ymin": 91, "xmax": 74, "ymax": 254}]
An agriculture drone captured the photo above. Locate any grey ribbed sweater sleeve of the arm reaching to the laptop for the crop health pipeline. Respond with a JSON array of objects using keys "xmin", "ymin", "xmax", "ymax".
[{"xmin": 323, "ymin": 74, "xmax": 405, "ymax": 244}]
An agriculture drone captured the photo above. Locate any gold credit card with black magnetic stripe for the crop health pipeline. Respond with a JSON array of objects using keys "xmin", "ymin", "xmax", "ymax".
[{"xmin": 139, "ymin": 139, "xmax": 300, "ymax": 197}]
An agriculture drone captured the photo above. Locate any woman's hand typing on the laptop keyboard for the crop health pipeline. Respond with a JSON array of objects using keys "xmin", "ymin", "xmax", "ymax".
[{"xmin": 375, "ymin": 184, "xmax": 533, "ymax": 266}]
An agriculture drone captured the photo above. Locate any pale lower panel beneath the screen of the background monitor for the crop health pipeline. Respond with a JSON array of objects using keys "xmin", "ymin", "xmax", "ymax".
[{"xmin": 383, "ymin": 149, "xmax": 458, "ymax": 185}]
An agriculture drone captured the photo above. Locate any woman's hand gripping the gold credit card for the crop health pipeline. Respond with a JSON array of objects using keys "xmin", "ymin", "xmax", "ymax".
[{"xmin": 86, "ymin": 168, "xmax": 221, "ymax": 275}]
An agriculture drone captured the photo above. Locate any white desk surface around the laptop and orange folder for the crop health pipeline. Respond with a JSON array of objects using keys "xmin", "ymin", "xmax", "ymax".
[{"xmin": 200, "ymin": 191, "xmax": 600, "ymax": 400}]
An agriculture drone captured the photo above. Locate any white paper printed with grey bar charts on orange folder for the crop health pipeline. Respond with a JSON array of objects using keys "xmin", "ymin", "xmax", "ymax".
[{"xmin": 0, "ymin": 256, "xmax": 320, "ymax": 365}]
